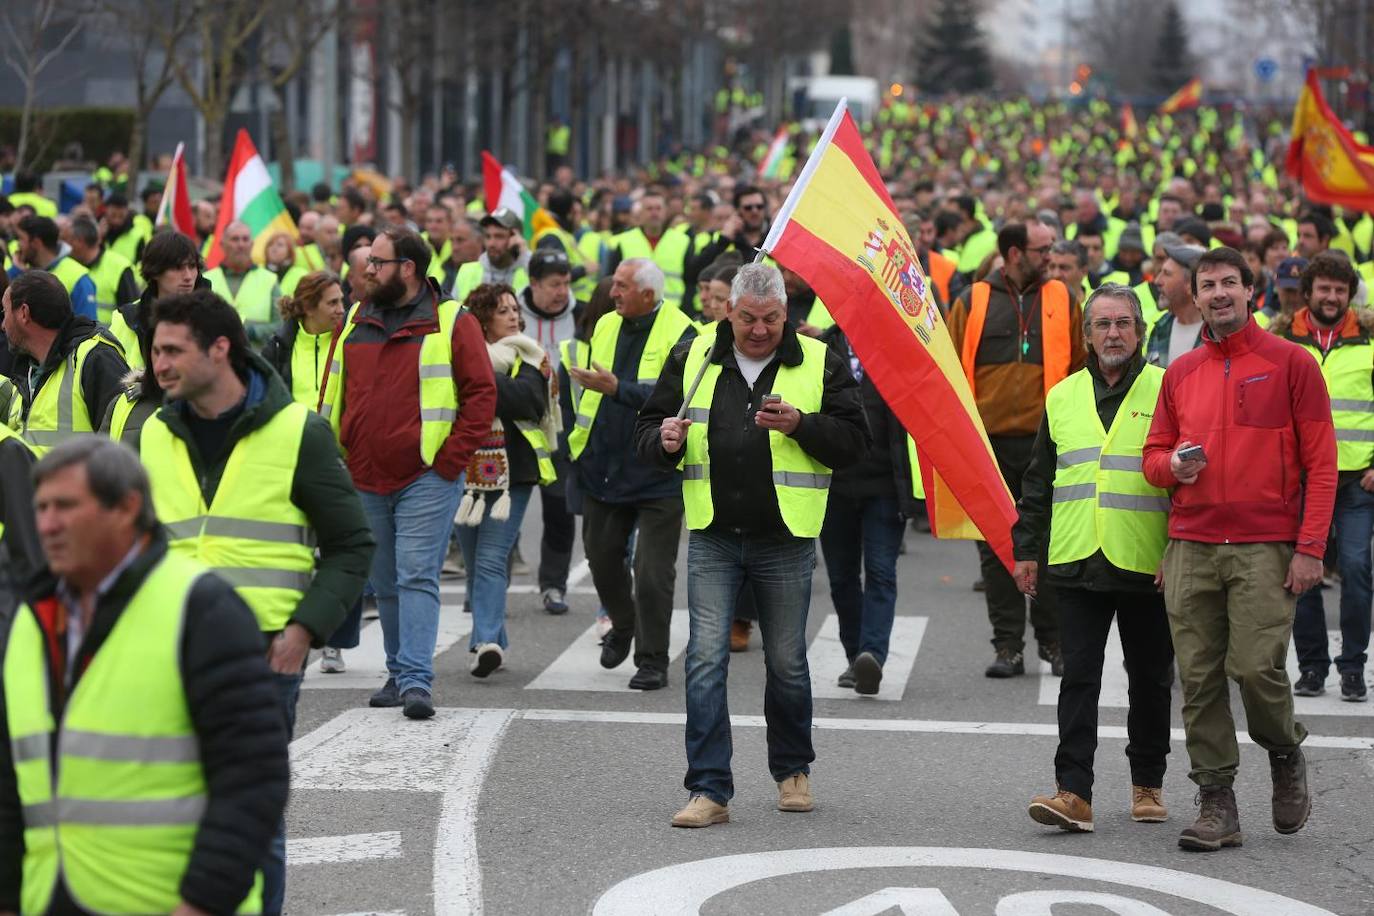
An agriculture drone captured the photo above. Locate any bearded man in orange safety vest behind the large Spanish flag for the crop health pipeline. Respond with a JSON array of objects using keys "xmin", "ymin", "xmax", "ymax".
[{"xmin": 948, "ymin": 222, "xmax": 1085, "ymax": 677}]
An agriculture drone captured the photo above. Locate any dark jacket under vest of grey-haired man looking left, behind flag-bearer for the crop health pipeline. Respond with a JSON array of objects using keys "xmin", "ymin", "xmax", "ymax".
[{"xmin": 567, "ymin": 312, "xmax": 697, "ymax": 504}]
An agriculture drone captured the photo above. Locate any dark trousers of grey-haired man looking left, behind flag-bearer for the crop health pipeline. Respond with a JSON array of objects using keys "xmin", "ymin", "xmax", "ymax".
[{"xmin": 583, "ymin": 496, "xmax": 683, "ymax": 672}]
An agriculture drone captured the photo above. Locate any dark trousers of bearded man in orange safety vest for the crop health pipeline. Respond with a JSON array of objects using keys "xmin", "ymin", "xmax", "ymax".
[{"xmin": 978, "ymin": 435, "xmax": 1059, "ymax": 652}]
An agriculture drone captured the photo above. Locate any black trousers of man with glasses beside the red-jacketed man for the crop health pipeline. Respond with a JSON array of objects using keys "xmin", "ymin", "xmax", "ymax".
[{"xmin": 1054, "ymin": 588, "xmax": 1173, "ymax": 802}]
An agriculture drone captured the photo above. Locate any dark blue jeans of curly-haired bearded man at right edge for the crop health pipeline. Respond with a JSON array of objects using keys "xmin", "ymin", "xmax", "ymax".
[{"xmin": 1293, "ymin": 479, "xmax": 1374, "ymax": 678}]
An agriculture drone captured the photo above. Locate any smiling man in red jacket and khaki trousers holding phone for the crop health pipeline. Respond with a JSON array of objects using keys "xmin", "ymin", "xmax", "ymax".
[{"xmin": 1143, "ymin": 247, "xmax": 1336, "ymax": 850}]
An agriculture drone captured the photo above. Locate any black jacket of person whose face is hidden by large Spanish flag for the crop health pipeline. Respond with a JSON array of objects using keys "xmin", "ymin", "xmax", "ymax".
[{"xmin": 820, "ymin": 324, "xmax": 919, "ymax": 518}]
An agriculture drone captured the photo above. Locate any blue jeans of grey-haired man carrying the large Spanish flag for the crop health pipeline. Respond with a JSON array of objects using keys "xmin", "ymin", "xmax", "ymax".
[{"xmin": 683, "ymin": 529, "xmax": 816, "ymax": 805}]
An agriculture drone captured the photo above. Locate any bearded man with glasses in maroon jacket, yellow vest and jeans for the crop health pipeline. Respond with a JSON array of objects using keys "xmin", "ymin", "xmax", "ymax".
[{"xmin": 320, "ymin": 227, "xmax": 496, "ymax": 718}]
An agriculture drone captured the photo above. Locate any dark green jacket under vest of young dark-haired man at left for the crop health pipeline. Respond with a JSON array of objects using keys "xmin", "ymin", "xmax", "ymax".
[{"xmin": 134, "ymin": 352, "xmax": 375, "ymax": 647}]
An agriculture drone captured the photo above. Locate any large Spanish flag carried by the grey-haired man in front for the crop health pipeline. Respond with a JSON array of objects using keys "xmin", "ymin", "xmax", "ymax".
[{"xmin": 763, "ymin": 100, "xmax": 1017, "ymax": 569}]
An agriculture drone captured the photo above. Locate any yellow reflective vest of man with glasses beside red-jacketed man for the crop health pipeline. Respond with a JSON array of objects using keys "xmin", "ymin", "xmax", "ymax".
[{"xmin": 1046, "ymin": 365, "xmax": 1169, "ymax": 575}]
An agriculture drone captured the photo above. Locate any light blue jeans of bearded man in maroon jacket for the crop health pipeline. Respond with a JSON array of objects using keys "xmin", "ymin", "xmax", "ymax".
[{"xmin": 360, "ymin": 471, "xmax": 463, "ymax": 694}]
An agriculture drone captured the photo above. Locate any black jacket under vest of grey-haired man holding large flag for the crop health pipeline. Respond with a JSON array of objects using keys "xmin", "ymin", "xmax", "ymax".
[{"xmin": 635, "ymin": 321, "xmax": 870, "ymax": 537}]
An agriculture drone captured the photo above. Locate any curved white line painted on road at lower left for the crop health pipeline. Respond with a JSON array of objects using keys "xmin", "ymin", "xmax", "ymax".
[{"xmin": 434, "ymin": 710, "xmax": 511, "ymax": 916}]
